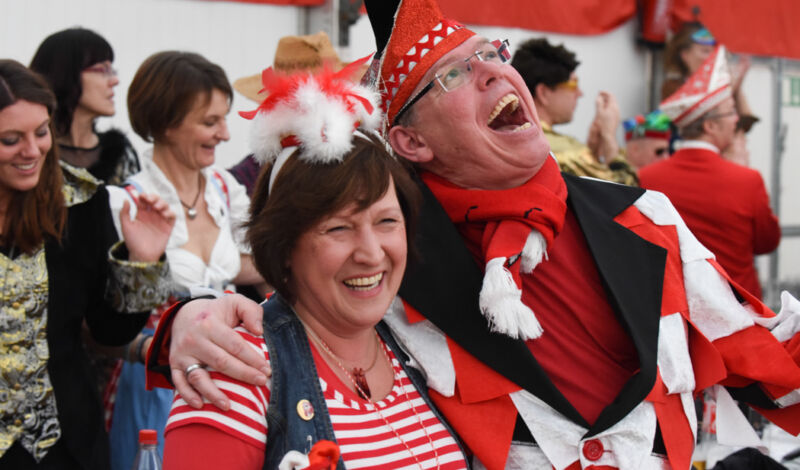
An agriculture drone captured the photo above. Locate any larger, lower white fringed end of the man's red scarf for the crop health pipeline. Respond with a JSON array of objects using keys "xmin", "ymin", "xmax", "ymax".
[{"xmin": 479, "ymin": 258, "xmax": 542, "ymax": 339}]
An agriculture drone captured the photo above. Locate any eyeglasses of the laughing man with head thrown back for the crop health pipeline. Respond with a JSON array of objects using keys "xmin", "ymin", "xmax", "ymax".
[{"xmin": 394, "ymin": 39, "xmax": 511, "ymax": 122}]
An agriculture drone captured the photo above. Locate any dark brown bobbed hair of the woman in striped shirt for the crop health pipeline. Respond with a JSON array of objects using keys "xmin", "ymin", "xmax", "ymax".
[{"xmin": 247, "ymin": 132, "xmax": 421, "ymax": 302}]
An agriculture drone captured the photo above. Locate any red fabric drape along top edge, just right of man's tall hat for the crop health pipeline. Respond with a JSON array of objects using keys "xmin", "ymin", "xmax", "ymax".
[{"xmin": 439, "ymin": 0, "xmax": 636, "ymax": 35}]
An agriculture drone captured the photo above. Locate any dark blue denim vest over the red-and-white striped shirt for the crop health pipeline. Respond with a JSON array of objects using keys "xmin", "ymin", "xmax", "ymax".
[{"xmin": 263, "ymin": 293, "xmax": 469, "ymax": 470}]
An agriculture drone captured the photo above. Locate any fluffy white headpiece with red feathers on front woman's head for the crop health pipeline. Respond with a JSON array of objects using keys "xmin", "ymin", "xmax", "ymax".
[{"xmin": 239, "ymin": 56, "xmax": 381, "ymax": 191}]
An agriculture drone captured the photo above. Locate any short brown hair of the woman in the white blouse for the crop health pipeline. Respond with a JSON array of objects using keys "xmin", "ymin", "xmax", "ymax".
[{"xmin": 128, "ymin": 51, "xmax": 233, "ymax": 142}]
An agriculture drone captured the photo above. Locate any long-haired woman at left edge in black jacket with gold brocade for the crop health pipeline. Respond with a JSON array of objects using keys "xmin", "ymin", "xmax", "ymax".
[{"xmin": 0, "ymin": 60, "xmax": 175, "ymax": 469}]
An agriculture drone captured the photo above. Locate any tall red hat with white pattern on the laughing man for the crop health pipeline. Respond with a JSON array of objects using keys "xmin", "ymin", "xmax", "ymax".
[{"xmin": 364, "ymin": 0, "xmax": 475, "ymax": 127}]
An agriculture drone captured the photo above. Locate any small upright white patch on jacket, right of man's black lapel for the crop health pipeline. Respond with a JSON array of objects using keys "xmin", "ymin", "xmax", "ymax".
[{"xmin": 658, "ymin": 313, "xmax": 695, "ymax": 393}]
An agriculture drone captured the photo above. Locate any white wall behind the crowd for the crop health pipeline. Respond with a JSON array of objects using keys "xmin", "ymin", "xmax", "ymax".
[{"xmin": 0, "ymin": 0, "xmax": 800, "ymax": 290}]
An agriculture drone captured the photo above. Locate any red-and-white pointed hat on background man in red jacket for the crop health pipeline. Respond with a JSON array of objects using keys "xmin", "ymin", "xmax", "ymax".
[{"xmin": 659, "ymin": 46, "xmax": 731, "ymax": 128}]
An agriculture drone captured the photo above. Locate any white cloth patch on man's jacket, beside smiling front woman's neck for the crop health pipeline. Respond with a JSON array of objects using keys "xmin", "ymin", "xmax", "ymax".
[{"xmin": 383, "ymin": 297, "xmax": 456, "ymax": 397}]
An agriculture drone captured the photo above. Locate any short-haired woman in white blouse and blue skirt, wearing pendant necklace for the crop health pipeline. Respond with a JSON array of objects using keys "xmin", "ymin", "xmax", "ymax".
[{"xmin": 105, "ymin": 51, "xmax": 264, "ymax": 470}]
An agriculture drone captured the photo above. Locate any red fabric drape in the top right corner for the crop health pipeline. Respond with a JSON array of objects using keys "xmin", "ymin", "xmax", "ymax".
[{"xmin": 672, "ymin": 0, "xmax": 800, "ymax": 59}]
